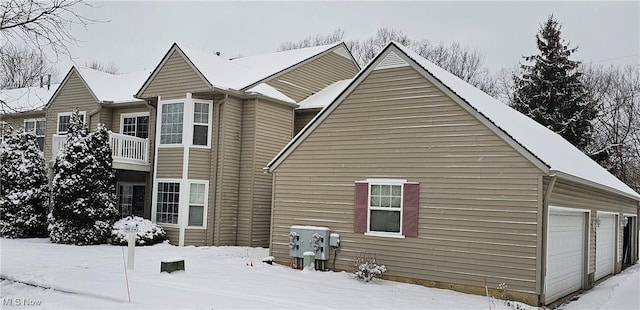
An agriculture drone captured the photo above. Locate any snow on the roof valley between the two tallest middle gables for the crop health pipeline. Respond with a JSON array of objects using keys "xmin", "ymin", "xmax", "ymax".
[{"xmin": 176, "ymin": 43, "xmax": 341, "ymax": 90}]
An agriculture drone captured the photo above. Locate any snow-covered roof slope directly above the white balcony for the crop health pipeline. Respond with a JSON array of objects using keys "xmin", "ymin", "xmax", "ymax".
[{"xmin": 77, "ymin": 67, "xmax": 149, "ymax": 103}]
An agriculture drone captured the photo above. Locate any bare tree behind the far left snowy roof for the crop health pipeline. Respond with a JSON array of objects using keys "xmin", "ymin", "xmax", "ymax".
[{"xmin": 0, "ymin": 46, "xmax": 58, "ymax": 89}]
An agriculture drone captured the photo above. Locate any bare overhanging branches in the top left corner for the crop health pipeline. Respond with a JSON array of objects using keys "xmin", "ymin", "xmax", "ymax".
[{"xmin": 0, "ymin": 0, "xmax": 95, "ymax": 57}]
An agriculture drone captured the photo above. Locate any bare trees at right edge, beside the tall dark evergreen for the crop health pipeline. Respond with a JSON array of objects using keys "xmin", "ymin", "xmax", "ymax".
[{"xmin": 582, "ymin": 65, "xmax": 640, "ymax": 191}]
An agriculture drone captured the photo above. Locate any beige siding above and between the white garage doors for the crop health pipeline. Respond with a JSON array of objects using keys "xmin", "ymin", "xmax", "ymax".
[{"xmin": 549, "ymin": 180, "xmax": 637, "ymax": 273}]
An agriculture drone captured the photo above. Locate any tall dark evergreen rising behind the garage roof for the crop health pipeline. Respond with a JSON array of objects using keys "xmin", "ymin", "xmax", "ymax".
[{"xmin": 512, "ymin": 15, "xmax": 597, "ymax": 151}]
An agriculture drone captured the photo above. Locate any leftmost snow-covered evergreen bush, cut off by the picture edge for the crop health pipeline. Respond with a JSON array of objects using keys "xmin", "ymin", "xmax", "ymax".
[{"xmin": 0, "ymin": 131, "xmax": 49, "ymax": 238}]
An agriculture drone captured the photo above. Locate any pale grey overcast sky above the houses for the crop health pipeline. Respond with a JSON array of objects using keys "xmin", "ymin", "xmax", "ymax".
[{"xmin": 58, "ymin": 1, "xmax": 640, "ymax": 77}]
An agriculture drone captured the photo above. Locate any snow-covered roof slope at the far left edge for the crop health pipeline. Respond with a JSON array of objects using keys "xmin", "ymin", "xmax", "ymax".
[{"xmin": 0, "ymin": 83, "xmax": 60, "ymax": 113}]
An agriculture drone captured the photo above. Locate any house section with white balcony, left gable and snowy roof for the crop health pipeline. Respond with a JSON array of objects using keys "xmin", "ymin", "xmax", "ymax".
[{"xmin": 44, "ymin": 66, "xmax": 155, "ymax": 218}]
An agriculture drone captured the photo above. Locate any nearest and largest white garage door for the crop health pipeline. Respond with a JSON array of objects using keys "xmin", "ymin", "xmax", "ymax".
[{"xmin": 545, "ymin": 209, "xmax": 585, "ymax": 303}]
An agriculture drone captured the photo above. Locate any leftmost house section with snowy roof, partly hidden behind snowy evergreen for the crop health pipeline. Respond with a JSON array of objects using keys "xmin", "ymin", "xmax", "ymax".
[{"xmin": 0, "ymin": 83, "xmax": 60, "ymax": 150}]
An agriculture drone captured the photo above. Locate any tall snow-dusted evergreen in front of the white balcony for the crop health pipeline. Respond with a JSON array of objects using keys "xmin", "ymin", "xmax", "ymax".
[{"xmin": 49, "ymin": 111, "xmax": 118, "ymax": 245}]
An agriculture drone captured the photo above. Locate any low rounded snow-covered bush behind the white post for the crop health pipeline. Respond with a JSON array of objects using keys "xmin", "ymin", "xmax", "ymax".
[{"xmin": 111, "ymin": 216, "xmax": 167, "ymax": 245}]
